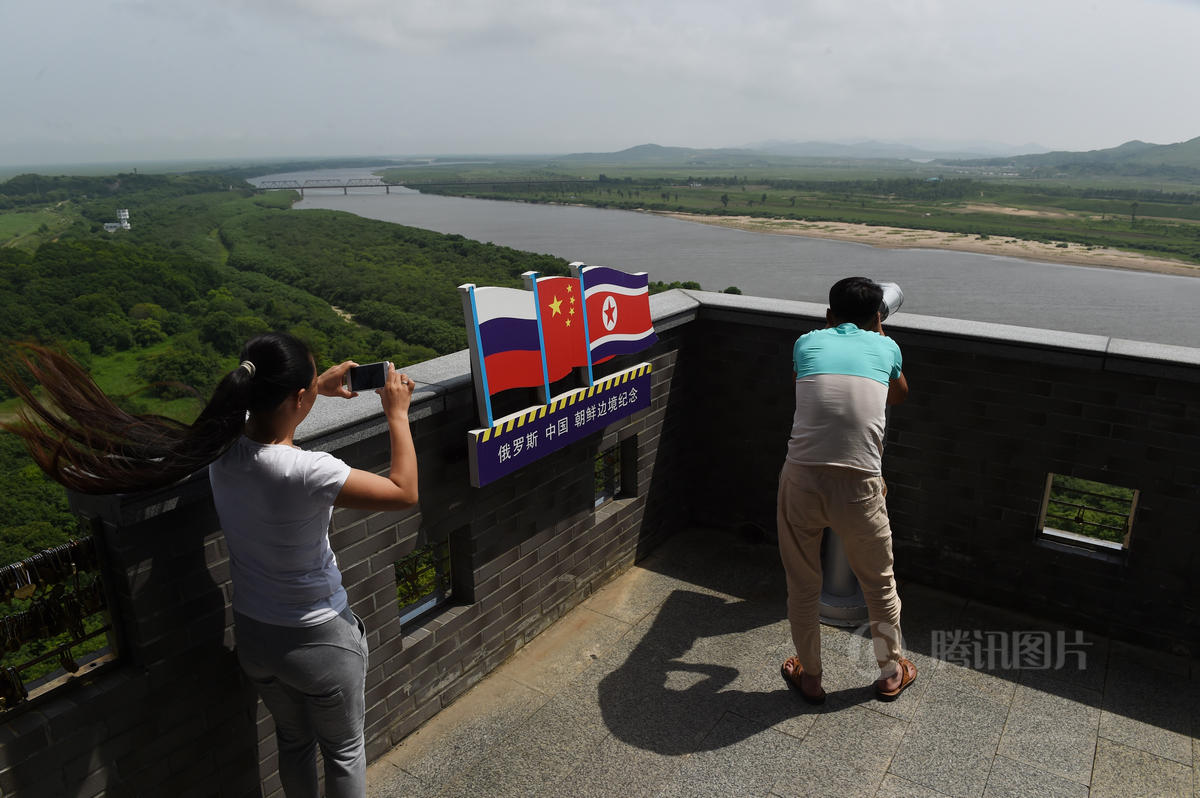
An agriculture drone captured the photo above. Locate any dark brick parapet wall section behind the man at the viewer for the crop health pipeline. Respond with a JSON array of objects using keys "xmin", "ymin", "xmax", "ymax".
[{"xmin": 685, "ymin": 296, "xmax": 1200, "ymax": 656}]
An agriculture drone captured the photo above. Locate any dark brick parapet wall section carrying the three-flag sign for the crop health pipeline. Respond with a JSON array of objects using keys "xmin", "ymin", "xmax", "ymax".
[{"xmin": 0, "ymin": 306, "xmax": 686, "ymax": 797}]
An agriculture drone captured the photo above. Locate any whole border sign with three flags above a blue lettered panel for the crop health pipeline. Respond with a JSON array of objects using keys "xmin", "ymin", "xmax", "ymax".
[{"xmin": 458, "ymin": 263, "xmax": 658, "ymax": 486}]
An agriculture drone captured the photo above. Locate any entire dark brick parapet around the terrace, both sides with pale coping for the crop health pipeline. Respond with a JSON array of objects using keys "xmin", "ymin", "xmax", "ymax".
[{"xmin": 0, "ymin": 292, "xmax": 1200, "ymax": 796}]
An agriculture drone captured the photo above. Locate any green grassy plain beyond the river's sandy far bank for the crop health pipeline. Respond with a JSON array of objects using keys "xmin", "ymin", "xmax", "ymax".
[{"xmin": 384, "ymin": 161, "xmax": 1200, "ymax": 264}]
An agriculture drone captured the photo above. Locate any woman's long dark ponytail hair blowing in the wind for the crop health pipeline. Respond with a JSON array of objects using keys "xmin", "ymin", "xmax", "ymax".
[{"xmin": 0, "ymin": 332, "xmax": 314, "ymax": 493}]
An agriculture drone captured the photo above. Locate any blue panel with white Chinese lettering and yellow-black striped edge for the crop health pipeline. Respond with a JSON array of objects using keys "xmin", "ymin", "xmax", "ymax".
[{"xmin": 467, "ymin": 362, "xmax": 650, "ymax": 487}]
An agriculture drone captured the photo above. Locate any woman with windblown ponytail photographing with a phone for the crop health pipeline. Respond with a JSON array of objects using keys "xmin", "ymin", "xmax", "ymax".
[{"xmin": 2, "ymin": 332, "xmax": 418, "ymax": 798}]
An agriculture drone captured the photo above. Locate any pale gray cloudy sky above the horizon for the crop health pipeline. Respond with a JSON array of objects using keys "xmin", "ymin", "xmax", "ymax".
[{"xmin": 0, "ymin": 0, "xmax": 1200, "ymax": 166}]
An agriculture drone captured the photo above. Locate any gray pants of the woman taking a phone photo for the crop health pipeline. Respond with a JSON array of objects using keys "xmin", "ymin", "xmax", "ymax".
[{"xmin": 234, "ymin": 610, "xmax": 367, "ymax": 798}]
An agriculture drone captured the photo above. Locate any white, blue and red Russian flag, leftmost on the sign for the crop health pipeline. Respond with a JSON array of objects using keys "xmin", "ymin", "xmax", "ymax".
[{"xmin": 470, "ymin": 287, "xmax": 542, "ymax": 396}]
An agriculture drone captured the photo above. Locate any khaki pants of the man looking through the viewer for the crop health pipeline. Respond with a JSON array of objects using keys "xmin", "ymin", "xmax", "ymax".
[{"xmin": 776, "ymin": 462, "xmax": 901, "ymax": 676}]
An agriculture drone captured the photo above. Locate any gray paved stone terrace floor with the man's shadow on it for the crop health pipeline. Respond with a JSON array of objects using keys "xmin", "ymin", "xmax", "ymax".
[{"xmin": 368, "ymin": 529, "xmax": 1200, "ymax": 798}]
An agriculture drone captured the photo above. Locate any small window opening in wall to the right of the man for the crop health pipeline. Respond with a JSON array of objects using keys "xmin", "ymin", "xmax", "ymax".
[{"xmin": 1040, "ymin": 474, "xmax": 1138, "ymax": 551}]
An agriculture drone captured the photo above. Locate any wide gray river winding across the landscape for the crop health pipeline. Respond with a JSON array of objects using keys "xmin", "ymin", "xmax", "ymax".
[{"xmin": 254, "ymin": 169, "xmax": 1200, "ymax": 348}]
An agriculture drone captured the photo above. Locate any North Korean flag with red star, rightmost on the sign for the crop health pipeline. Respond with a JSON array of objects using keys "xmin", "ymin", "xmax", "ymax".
[{"xmin": 578, "ymin": 266, "xmax": 659, "ymax": 362}]
